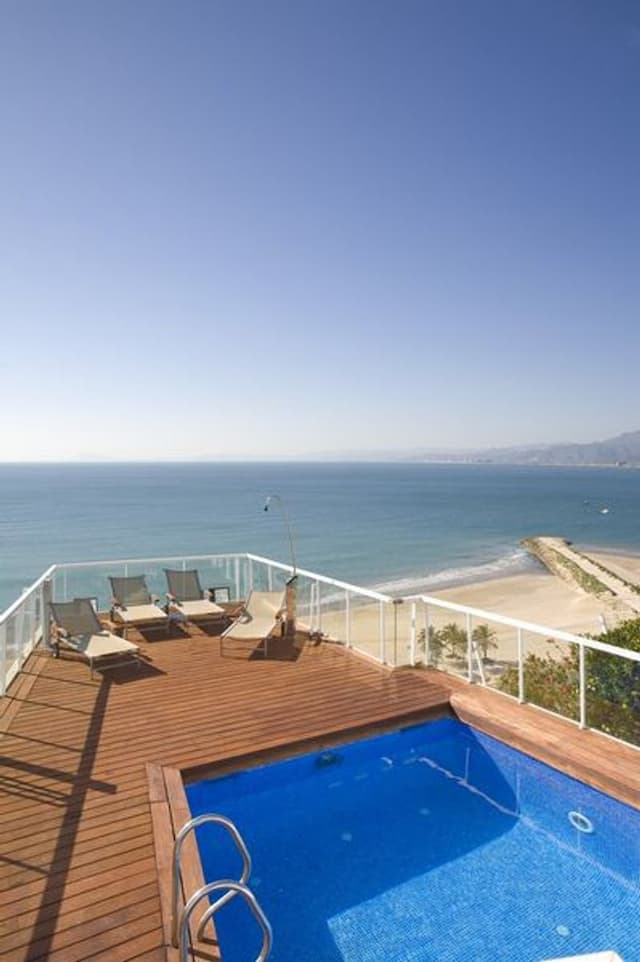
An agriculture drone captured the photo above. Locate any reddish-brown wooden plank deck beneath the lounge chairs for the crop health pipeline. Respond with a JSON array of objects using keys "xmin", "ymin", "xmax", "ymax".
[{"xmin": 0, "ymin": 629, "xmax": 448, "ymax": 962}]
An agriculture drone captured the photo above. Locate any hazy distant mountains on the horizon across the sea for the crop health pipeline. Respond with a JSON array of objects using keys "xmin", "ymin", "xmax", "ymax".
[{"xmin": 410, "ymin": 431, "xmax": 640, "ymax": 467}]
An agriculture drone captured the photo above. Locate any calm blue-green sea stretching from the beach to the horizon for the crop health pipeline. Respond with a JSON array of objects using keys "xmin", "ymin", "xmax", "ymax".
[{"xmin": 0, "ymin": 463, "xmax": 640, "ymax": 609}]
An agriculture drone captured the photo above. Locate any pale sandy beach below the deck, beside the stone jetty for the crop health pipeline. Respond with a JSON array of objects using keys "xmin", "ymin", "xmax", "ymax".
[{"xmin": 322, "ymin": 552, "xmax": 640, "ymax": 668}]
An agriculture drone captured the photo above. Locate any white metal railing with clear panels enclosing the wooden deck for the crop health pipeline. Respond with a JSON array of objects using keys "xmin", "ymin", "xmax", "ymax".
[{"xmin": 0, "ymin": 552, "xmax": 640, "ymax": 748}]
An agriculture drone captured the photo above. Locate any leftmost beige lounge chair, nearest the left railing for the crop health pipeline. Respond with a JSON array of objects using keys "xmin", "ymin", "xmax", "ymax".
[{"xmin": 49, "ymin": 598, "xmax": 140, "ymax": 678}]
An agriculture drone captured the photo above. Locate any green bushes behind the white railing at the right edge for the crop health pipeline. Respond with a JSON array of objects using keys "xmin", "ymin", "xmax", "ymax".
[{"xmin": 498, "ymin": 619, "xmax": 640, "ymax": 745}]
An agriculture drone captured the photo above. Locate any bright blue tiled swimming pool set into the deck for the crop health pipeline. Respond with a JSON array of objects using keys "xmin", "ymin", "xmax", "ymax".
[{"xmin": 187, "ymin": 719, "xmax": 640, "ymax": 962}]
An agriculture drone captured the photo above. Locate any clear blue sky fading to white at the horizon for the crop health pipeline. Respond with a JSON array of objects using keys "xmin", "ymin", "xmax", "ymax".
[{"xmin": 0, "ymin": 0, "xmax": 640, "ymax": 460}]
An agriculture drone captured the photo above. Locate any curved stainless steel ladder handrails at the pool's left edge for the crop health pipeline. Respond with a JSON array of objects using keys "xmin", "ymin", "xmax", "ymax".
[{"xmin": 171, "ymin": 813, "xmax": 273, "ymax": 962}]
